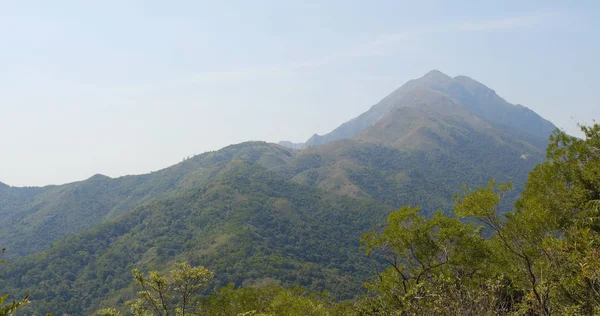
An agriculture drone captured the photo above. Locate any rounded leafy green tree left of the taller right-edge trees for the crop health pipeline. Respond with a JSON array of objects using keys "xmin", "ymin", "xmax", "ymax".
[{"xmin": 359, "ymin": 206, "xmax": 496, "ymax": 315}]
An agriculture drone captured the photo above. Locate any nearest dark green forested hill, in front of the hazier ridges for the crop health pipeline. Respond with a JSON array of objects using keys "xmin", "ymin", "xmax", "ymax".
[{"xmin": 2, "ymin": 160, "xmax": 391, "ymax": 315}]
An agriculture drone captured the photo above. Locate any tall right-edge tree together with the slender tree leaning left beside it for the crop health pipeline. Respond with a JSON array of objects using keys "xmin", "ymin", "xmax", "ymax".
[{"xmin": 456, "ymin": 124, "xmax": 600, "ymax": 315}]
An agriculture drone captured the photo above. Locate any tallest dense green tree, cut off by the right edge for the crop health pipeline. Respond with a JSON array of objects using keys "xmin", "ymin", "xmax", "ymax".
[{"xmin": 515, "ymin": 124, "xmax": 600, "ymax": 314}]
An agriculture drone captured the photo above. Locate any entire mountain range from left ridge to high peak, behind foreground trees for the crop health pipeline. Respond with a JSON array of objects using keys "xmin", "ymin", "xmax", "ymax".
[{"xmin": 0, "ymin": 71, "xmax": 555, "ymax": 314}]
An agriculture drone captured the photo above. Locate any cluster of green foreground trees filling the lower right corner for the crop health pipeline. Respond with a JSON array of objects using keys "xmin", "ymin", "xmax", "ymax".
[{"xmin": 363, "ymin": 125, "xmax": 600, "ymax": 315}]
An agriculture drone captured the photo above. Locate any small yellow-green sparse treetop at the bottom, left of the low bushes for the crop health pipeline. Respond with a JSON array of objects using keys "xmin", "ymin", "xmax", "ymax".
[{"xmin": 129, "ymin": 263, "xmax": 213, "ymax": 316}]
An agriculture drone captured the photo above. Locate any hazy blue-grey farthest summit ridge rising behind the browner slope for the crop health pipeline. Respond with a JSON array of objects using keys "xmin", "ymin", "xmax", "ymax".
[{"xmin": 305, "ymin": 70, "xmax": 556, "ymax": 147}]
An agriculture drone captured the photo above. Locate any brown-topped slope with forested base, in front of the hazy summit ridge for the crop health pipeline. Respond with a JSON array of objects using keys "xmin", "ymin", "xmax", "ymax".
[{"xmin": 276, "ymin": 78, "xmax": 544, "ymax": 211}]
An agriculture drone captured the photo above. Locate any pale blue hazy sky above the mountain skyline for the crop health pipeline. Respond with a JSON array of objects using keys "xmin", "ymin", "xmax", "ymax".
[{"xmin": 0, "ymin": 0, "xmax": 600, "ymax": 186}]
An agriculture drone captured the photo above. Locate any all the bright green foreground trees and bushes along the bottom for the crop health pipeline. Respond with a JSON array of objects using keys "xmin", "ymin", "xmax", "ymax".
[{"xmin": 81, "ymin": 125, "xmax": 600, "ymax": 315}]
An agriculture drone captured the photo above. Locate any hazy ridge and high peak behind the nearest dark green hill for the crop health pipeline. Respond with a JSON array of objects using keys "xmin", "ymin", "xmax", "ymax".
[{"xmin": 0, "ymin": 71, "xmax": 554, "ymax": 258}]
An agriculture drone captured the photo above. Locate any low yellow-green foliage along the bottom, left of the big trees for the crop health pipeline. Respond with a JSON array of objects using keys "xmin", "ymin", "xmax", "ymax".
[{"xmin": 94, "ymin": 270, "xmax": 352, "ymax": 316}]
